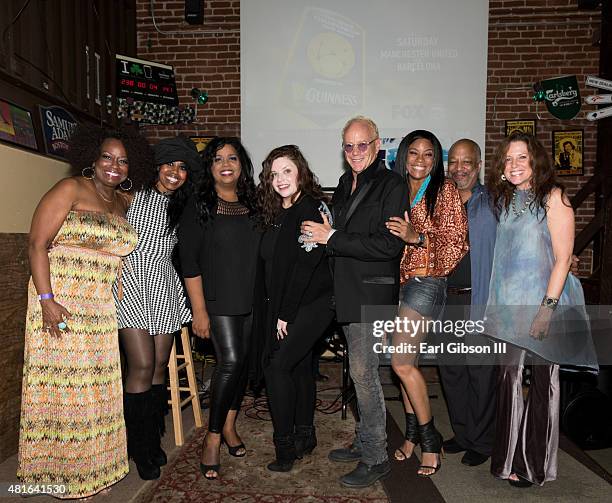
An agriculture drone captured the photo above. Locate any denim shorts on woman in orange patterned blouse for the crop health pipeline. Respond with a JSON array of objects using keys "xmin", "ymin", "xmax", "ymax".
[{"xmin": 400, "ymin": 276, "xmax": 446, "ymax": 319}]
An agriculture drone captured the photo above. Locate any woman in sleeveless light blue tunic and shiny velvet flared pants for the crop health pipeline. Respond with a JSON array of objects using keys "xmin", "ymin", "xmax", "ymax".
[{"xmin": 485, "ymin": 133, "xmax": 597, "ymax": 487}]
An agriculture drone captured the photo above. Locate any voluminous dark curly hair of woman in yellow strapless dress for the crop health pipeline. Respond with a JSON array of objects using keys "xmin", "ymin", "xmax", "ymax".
[{"xmin": 68, "ymin": 124, "xmax": 156, "ymax": 192}]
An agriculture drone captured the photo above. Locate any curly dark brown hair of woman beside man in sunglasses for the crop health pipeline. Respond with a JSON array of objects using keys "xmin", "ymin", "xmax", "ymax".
[{"xmin": 257, "ymin": 145, "xmax": 325, "ymax": 227}]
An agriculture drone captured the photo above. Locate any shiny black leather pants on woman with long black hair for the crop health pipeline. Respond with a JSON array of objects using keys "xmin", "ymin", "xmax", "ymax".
[{"xmin": 208, "ymin": 314, "xmax": 252, "ymax": 433}]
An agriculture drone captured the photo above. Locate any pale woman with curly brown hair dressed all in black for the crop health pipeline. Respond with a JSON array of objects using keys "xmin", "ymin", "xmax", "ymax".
[{"xmin": 258, "ymin": 145, "xmax": 333, "ymax": 471}]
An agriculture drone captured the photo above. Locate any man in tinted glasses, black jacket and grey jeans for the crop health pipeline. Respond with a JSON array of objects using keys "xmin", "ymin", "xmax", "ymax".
[{"xmin": 302, "ymin": 116, "xmax": 409, "ymax": 487}]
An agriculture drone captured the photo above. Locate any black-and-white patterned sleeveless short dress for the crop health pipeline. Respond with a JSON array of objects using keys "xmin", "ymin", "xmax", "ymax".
[{"xmin": 115, "ymin": 189, "xmax": 191, "ymax": 335}]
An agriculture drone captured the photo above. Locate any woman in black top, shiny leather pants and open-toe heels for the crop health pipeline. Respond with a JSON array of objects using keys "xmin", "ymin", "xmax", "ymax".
[{"xmin": 179, "ymin": 138, "xmax": 260, "ymax": 479}]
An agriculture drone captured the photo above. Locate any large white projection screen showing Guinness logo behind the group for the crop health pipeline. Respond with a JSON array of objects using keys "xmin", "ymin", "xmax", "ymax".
[{"xmin": 240, "ymin": 0, "xmax": 488, "ymax": 187}]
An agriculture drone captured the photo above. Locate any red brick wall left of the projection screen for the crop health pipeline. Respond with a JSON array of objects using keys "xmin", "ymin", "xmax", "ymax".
[{"xmin": 137, "ymin": 0, "xmax": 240, "ymax": 142}]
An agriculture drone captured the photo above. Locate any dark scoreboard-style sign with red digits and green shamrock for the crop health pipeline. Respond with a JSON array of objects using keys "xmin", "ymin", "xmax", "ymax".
[{"xmin": 116, "ymin": 54, "xmax": 178, "ymax": 106}]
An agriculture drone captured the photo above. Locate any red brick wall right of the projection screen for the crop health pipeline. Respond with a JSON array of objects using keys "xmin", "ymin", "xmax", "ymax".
[{"xmin": 485, "ymin": 0, "xmax": 601, "ymax": 275}]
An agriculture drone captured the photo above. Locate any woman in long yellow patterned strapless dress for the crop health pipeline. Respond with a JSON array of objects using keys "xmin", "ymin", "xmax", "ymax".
[{"xmin": 17, "ymin": 127, "xmax": 154, "ymax": 498}]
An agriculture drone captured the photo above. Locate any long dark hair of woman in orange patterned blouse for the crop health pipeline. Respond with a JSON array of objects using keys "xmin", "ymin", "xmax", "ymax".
[{"xmin": 393, "ymin": 129, "xmax": 444, "ymax": 218}]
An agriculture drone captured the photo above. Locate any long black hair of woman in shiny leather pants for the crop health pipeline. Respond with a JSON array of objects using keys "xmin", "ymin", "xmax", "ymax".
[{"xmin": 194, "ymin": 136, "xmax": 257, "ymax": 224}]
